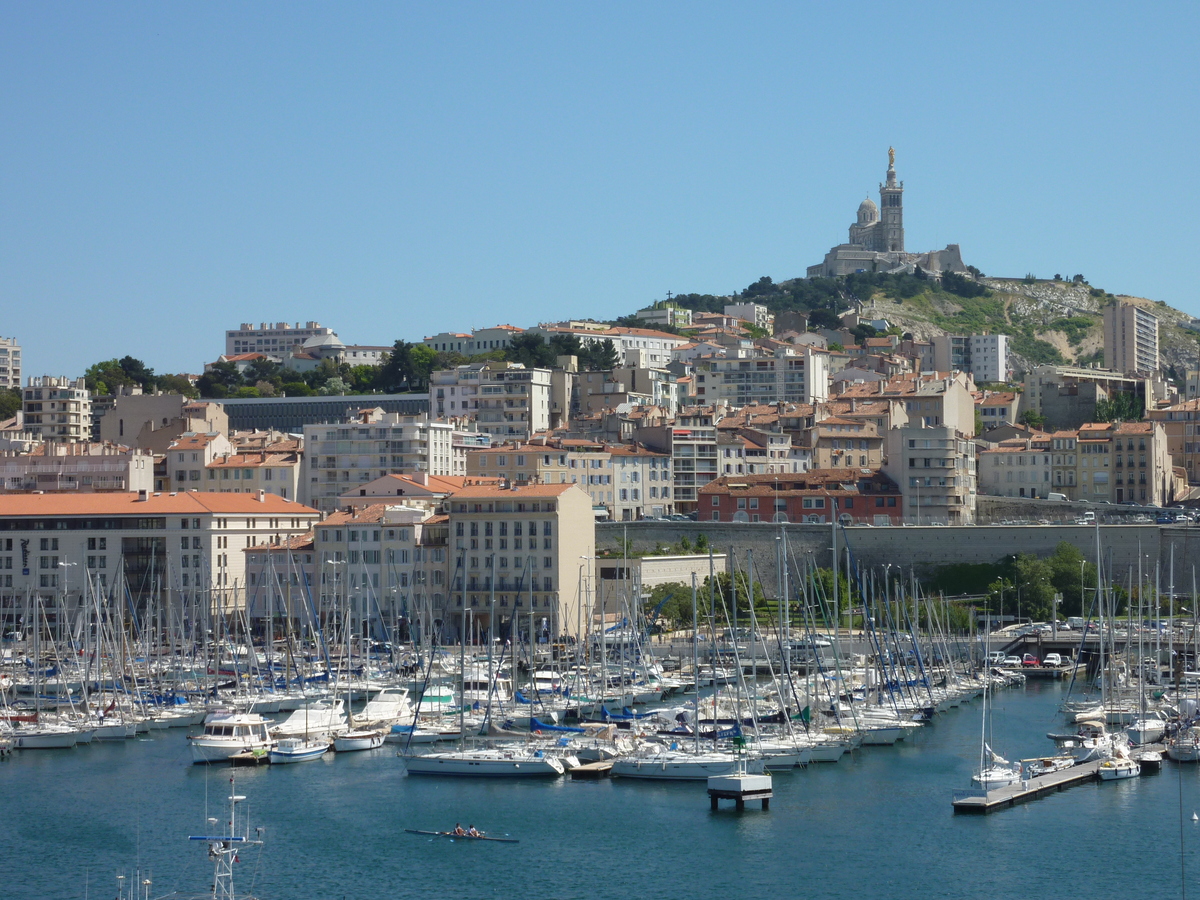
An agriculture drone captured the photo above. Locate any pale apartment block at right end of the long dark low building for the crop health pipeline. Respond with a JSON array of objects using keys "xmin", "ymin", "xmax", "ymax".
[{"xmin": 430, "ymin": 361, "xmax": 551, "ymax": 440}]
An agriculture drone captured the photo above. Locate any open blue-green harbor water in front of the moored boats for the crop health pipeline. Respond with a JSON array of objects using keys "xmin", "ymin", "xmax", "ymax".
[{"xmin": 7, "ymin": 682, "xmax": 1200, "ymax": 900}]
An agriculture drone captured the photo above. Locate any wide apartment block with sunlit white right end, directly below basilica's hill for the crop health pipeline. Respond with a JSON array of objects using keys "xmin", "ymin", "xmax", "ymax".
[{"xmin": 697, "ymin": 344, "xmax": 829, "ymax": 407}]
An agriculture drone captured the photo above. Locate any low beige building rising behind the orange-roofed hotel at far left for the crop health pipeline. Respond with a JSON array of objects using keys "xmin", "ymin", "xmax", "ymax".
[{"xmin": 0, "ymin": 440, "xmax": 154, "ymax": 493}]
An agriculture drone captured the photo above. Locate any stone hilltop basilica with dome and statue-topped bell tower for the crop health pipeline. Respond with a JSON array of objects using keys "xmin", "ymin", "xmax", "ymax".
[{"xmin": 806, "ymin": 148, "xmax": 967, "ymax": 278}]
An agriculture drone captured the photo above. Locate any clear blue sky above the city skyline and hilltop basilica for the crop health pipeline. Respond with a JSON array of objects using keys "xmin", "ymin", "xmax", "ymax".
[{"xmin": 0, "ymin": 0, "xmax": 1200, "ymax": 376}]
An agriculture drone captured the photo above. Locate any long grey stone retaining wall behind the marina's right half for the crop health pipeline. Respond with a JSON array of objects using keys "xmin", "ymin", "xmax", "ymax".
[{"xmin": 596, "ymin": 522, "xmax": 1200, "ymax": 589}]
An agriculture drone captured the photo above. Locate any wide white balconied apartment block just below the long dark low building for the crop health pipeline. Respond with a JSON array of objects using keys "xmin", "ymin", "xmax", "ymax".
[{"xmin": 299, "ymin": 410, "xmax": 468, "ymax": 512}]
